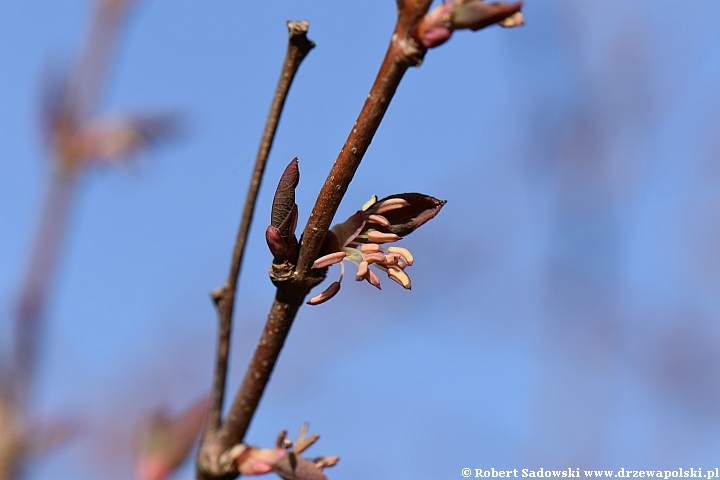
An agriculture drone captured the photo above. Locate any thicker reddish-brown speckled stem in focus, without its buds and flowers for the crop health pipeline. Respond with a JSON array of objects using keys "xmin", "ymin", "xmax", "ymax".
[{"xmin": 210, "ymin": 0, "xmax": 431, "ymax": 464}]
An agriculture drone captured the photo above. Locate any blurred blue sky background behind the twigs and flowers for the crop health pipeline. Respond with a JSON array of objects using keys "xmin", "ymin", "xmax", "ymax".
[{"xmin": 0, "ymin": 0, "xmax": 720, "ymax": 479}]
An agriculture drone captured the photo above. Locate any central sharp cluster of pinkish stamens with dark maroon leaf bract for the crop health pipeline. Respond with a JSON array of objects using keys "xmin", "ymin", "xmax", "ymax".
[{"xmin": 308, "ymin": 193, "xmax": 445, "ymax": 305}]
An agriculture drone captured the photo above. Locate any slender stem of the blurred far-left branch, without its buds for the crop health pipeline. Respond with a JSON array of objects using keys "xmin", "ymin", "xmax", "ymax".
[{"xmin": 12, "ymin": 0, "xmax": 130, "ymax": 416}]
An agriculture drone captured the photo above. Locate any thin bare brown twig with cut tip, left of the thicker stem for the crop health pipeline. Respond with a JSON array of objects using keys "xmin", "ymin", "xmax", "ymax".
[{"xmin": 205, "ymin": 21, "xmax": 315, "ymax": 433}]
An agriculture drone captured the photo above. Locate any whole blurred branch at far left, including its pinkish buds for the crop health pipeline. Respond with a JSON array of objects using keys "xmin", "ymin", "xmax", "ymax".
[{"xmin": 0, "ymin": 0, "xmax": 176, "ymax": 479}]
